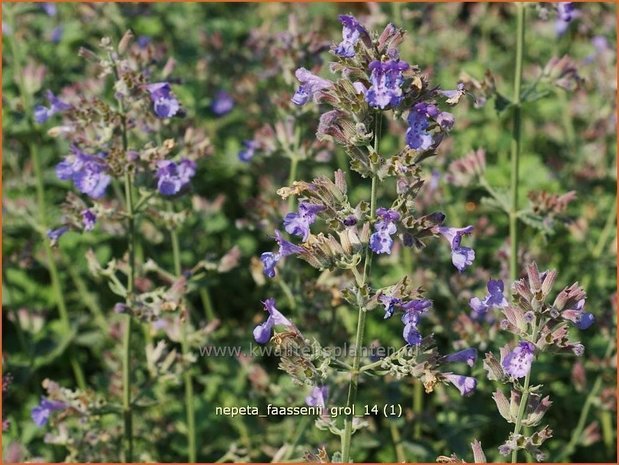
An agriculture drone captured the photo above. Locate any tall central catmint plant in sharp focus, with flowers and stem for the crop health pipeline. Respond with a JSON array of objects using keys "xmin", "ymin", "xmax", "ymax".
[{"xmin": 254, "ymin": 15, "xmax": 477, "ymax": 462}]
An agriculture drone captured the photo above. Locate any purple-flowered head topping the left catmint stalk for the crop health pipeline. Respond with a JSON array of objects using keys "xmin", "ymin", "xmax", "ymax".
[{"xmin": 34, "ymin": 36, "xmax": 200, "ymax": 244}]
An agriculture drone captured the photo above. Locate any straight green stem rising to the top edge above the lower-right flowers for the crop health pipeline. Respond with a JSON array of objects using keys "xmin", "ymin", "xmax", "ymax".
[{"xmin": 509, "ymin": 3, "xmax": 525, "ymax": 281}]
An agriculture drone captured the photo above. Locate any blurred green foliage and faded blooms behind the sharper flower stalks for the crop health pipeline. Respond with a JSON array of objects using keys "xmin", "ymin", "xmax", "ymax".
[{"xmin": 2, "ymin": 3, "xmax": 617, "ymax": 462}]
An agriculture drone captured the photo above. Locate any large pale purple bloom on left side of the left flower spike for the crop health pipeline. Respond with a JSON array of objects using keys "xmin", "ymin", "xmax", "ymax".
[{"xmin": 56, "ymin": 146, "xmax": 111, "ymax": 199}]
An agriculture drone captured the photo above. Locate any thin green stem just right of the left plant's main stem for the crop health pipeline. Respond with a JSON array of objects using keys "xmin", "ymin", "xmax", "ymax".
[{"xmin": 170, "ymin": 222, "xmax": 196, "ymax": 463}]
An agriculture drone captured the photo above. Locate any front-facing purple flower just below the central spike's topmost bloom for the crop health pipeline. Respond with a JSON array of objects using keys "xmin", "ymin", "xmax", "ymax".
[{"xmin": 365, "ymin": 60, "xmax": 409, "ymax": 109}]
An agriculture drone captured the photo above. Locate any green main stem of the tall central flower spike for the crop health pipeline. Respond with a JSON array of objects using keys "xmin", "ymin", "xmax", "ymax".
[{"xmin": 342, "ymin": 113, "xmax": 381, "ymax": 463}]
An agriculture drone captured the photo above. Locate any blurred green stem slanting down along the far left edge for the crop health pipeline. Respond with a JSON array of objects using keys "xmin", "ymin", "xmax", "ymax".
[{"xmin": 6, "ymin": 8, "xmax": 86, "ymax": 390}]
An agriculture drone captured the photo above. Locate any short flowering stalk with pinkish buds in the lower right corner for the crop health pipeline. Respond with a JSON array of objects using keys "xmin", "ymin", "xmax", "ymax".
[{"xmin": 484, "ymin": 263, "xmax": 595, "ymax": 463}]
